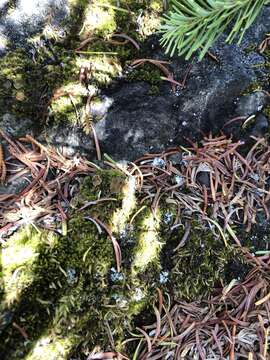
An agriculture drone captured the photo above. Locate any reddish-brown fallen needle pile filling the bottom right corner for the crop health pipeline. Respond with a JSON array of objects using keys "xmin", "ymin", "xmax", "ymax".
[{"xmin": 129, "ymin": 268, "xmax": 270, "ymax": 360}]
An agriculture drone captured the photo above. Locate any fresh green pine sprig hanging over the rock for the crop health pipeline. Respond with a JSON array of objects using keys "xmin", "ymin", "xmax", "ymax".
[{"xmin": 161, "ymin": 0, "xmax": 270, "ymax": 60}]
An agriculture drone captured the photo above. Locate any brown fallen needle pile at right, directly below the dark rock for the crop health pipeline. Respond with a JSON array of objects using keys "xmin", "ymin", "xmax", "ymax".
[{"xmin": 127, "ymin": 136, "xmax": 270, "ymax": 245}]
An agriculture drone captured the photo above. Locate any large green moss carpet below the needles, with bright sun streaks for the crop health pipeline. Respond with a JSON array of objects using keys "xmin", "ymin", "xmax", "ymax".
[{"xmin": 0, "ymin": 168, "xmax": 255, "ymax": 360}]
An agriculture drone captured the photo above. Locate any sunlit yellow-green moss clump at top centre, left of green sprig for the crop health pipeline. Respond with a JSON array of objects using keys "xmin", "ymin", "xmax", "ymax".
[{"xmin": 71, "ymin": 0, "xmax": 163, "ymax": 90}]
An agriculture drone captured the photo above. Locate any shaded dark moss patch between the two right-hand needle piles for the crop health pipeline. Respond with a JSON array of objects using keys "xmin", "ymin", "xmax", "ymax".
[{"xmin": 159, "ymin": 221, "xmax": 250, "ymax": 300}]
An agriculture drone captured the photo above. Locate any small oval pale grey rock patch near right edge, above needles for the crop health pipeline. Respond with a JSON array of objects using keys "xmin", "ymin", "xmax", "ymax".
[{"xmin": 236, "ymin": 91, "xmax": 270, "ymax": 116}]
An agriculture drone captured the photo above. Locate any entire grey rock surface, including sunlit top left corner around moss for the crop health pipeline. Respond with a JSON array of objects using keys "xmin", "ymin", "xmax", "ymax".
[{"xmin": 0, "ymin": 0, "xmax": 270, "ymax": 160}]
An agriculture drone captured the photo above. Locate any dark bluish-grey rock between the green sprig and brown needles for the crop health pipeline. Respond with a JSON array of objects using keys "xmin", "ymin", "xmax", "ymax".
[{"xmin": 93, "ymin": 7, "xmax": 270, "ymax": 160}]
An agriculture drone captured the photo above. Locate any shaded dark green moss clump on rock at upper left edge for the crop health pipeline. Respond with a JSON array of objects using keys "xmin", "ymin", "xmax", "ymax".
[{"xmin": 0, "ymin": 45, "xmax": 80, "ymax": 125}]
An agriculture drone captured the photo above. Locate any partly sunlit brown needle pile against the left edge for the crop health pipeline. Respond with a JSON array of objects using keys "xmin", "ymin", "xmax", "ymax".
[{"xmin": 0, "ymin": 130, "xmax": 96, "ymax": 235}]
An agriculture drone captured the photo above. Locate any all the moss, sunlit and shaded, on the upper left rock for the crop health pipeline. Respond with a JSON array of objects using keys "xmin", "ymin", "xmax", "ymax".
[{"xmin": 0, "ymin": 0, "xmax": 163, "ymax": 131}]
